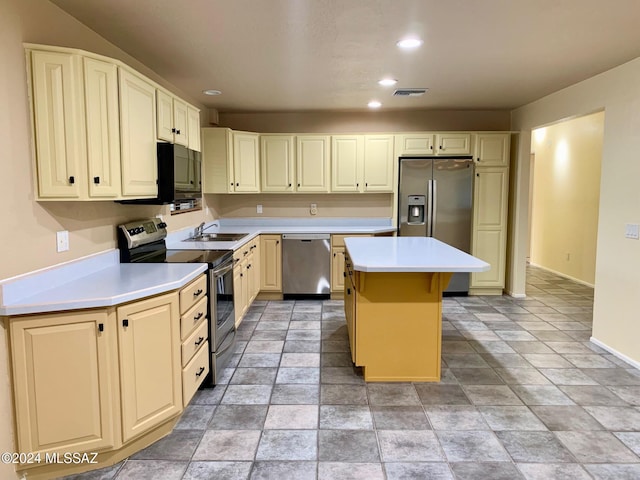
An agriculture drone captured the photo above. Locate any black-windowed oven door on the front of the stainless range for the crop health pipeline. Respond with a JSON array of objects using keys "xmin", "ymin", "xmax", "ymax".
[{"xmin": 209, "ymin": 259, "xmax": 235, "ymax": 352}]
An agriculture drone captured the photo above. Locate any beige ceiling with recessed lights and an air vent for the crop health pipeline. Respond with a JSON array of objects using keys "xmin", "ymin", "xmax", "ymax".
[{"xmin": 52, "ymin": 0, "xmax": 640, "ymax": 112}]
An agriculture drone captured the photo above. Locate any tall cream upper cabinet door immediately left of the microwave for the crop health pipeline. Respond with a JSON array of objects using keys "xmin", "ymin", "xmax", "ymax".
[{"xmin": 118, "ymin": 68, "xmax": 158, "ymax": 197}]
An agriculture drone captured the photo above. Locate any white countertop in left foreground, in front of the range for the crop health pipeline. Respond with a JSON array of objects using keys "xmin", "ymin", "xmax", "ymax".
[{"xmin": 0, "ymin": 256, "xmax": 207, "ymax": 316}]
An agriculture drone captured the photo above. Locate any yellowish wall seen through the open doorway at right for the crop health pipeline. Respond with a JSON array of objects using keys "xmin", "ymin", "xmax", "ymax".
[{"xmin": 530, "ymin": 112, "xmax": 604, "ymax": 285}]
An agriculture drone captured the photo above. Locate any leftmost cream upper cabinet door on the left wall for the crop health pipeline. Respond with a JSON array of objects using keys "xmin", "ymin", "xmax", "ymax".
[{"xmin": 31, "ymin": 51, "xmax": 86, "ymax": 198}]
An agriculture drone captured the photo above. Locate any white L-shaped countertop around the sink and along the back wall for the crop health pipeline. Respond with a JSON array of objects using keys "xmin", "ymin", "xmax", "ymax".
[{"xmin": 166, "ymin": 218, "xmax": 396, "ymax": 250}]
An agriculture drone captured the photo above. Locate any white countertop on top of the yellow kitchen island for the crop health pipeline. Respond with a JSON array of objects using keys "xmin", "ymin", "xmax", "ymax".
[{"xmin": 345, "ymin": 237, "xmax": 491, "ymax": 272}]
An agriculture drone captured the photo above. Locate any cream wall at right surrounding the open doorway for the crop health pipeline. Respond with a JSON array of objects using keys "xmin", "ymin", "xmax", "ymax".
[{"xmin": 509, "ymin": 58, "xmax": 640, "ymax": 362}]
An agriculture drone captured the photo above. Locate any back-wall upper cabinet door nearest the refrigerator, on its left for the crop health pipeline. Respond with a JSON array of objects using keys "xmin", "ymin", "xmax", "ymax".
[{"xmin": 364, "ymin": 135, "xmax": 394, "ymax": 192}]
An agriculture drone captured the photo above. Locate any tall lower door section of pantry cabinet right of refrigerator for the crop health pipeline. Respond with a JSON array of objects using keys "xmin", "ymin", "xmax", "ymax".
[{"xmin": 469, "ymin": 167, "xmax": 509, "ymax": 295}]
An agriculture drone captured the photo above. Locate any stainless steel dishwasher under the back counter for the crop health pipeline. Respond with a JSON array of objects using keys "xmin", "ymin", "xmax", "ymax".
[{"xmin": 282, "ymin": 233, "xmax": 331, "ymax": 299}]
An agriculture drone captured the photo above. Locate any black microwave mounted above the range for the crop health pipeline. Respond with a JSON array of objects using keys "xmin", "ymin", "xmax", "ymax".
[{"xmin": 119, "ymin": 143, "xmax": 202, "ymax": 205}]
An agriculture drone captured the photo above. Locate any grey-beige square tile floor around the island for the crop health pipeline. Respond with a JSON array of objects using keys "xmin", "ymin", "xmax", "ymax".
[{"xmin": 66, "ymin": 267, "xmax": 640, "ymax": 480}]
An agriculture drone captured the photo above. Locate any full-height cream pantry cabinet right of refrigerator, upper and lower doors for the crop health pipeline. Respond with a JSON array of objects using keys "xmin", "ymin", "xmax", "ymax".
[{"xmin": 469, "ymin": 133, "xmax": 509, "ymax": 295}]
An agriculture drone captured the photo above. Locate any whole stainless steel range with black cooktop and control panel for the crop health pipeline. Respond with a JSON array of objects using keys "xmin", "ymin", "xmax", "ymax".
[{"xmin": 118, "ymin": 218, "xmax": 236, "ymax": 385}]
